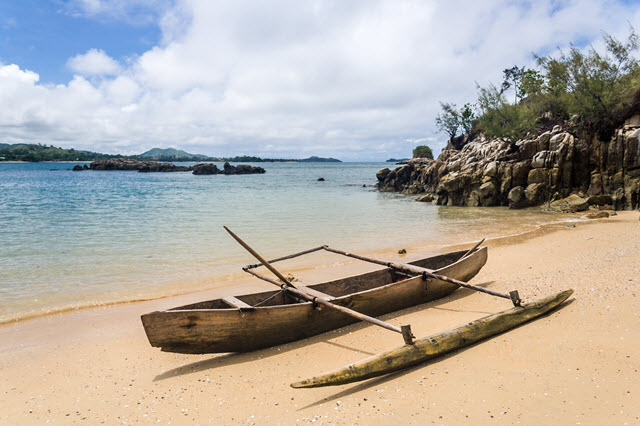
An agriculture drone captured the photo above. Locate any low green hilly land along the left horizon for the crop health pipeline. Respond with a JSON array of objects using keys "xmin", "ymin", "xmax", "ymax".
[{"xmin": 0, "ymin": 143, "xmax": 341, "ymax": 163}]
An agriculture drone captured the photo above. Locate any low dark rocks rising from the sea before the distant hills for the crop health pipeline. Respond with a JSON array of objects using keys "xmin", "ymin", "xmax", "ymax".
[{"xmin": 90, "ymin": 158, "xmax": 265, "ymax": 175}]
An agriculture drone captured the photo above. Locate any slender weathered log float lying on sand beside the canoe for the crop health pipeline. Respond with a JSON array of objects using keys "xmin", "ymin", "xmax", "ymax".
[{"xmin": 291, "ymin": 290, "xmax": 573, "ymax": 388}]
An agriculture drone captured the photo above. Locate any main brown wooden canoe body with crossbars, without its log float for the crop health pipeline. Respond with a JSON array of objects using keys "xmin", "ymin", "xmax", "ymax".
[{"xmin": 142, "ymin": 243, "xmax": 488, "ymax": 354}]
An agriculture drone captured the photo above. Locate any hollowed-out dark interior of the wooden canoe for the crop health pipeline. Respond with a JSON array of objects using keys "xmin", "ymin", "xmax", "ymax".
[{"xmin": 169, "ymin": 251, "xmax": 466, "ymax": 311}]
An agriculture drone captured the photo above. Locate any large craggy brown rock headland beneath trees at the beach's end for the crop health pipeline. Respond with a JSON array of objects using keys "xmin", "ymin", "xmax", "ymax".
[{"xmin": 376, "ymin": 119, "xmax": 640, "ymax": 209}]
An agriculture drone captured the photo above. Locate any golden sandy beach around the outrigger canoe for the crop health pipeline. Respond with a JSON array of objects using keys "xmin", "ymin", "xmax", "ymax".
[{"xmin": 0, "ymin": 211, "xmax": 640, "ymax": 425}]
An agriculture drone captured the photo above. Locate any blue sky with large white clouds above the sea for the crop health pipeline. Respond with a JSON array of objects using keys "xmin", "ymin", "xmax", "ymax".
[{"xmin": 0, "ymin": 0, "xmax": 640, "ymax": 161}]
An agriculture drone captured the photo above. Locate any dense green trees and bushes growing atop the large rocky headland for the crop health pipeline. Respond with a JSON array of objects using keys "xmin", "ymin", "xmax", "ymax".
[{"xmin": 477, "ymin": 28, "xmax": 640, "ymax": 139}]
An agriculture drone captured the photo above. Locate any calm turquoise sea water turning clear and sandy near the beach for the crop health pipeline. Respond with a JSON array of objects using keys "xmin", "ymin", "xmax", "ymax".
[{"xmin": 0, "ymin": 163, "xmax": 556, "ymax": 322}]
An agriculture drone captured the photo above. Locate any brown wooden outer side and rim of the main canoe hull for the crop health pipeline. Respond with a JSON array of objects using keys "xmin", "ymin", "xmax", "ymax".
[{"xmin": 142, "ymin": 247, "xmax": 487, "ymax": 353}]
